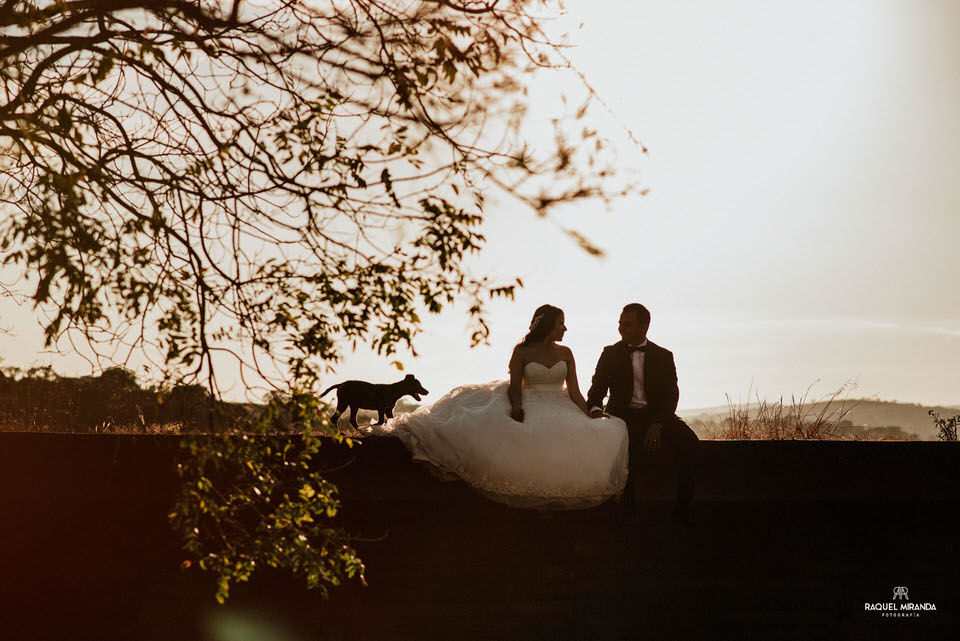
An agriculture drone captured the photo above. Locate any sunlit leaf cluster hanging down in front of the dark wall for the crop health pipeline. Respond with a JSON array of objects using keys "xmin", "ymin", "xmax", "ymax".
[{"xmin": 169, "ymin": 428, "xmax": 365, "ymax": 603}]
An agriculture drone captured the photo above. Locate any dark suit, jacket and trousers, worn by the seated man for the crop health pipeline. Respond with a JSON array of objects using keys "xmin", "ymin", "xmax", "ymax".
[{"xmin": 587, "ymin": 340, "xmax": 700, "ymax": 513}]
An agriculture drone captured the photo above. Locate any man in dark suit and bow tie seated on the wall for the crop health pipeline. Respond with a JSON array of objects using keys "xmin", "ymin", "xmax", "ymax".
[{"xmin": 587, "ymin": 303, "xmax": 700, "ymax": 527}]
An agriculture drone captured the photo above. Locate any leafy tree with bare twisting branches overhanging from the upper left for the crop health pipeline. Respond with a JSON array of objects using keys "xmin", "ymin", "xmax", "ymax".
[{"xmin": 0, "ymin": 0, "xmax": 629, "ymax": 599}]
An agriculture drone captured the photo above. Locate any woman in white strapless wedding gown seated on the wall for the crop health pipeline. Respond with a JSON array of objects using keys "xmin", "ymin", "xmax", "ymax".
[{"xmin": 387, "ymin": 305, "xmax": 627, "ymax": 509}]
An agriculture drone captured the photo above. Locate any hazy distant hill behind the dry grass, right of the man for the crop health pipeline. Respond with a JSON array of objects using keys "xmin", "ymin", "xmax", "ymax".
[{"xmin": 677, "ymin": 399, "xmax": 960, "ymax": 441}]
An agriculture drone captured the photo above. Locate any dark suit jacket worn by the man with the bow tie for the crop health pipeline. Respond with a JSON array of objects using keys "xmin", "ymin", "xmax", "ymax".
[{"xmin": 587, "ymin": 340, "xmax": 680, "ymax": 425}]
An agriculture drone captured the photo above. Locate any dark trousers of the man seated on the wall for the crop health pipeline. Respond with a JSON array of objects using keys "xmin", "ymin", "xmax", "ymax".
[{"xmin": 623, "ymin": 408, "xmax": 700, "ymax": 514}]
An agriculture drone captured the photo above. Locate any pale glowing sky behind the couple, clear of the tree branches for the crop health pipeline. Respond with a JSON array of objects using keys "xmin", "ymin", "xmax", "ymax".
[{"xmin": 0, "ymin": 0, "xmax": 960, "ymax": 409}]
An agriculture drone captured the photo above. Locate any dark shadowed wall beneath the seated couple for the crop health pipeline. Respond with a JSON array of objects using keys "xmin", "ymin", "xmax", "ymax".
[{"xmin": 0, "ymin": 434, "xmax": 960, "ymax": 640}]
